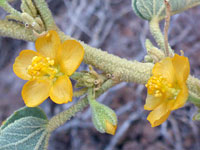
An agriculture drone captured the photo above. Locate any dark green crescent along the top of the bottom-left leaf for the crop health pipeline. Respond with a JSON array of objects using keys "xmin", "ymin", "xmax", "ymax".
[{"xmin": 0, "ymin": 107, "xmax": 47, "ymax": 131}]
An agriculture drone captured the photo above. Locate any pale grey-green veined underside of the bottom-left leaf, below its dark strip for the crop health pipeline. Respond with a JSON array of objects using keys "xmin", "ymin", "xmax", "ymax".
[{"xmin": 0, "ymin": 117, "xmax": 48, "ymax": 150}]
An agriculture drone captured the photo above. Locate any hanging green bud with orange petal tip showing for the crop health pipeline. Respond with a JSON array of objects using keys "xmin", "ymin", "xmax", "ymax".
[{"xmin": 89, "ymin": 100, "xmax": 117, "ymax": 135}]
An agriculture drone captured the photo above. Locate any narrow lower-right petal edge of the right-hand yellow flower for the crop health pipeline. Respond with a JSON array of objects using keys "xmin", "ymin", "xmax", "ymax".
[{"xmin": 171, "ymin": 84, "xmax": 189, "ymax": 110}]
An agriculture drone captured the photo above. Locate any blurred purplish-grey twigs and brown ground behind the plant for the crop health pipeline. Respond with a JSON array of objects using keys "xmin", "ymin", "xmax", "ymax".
[{"xmin": 0, "ymin": 0, "xmax": 200, "ymax": 150}]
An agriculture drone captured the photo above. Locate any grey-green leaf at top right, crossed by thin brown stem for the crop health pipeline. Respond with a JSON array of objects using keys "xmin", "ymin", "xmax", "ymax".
[{"xmin": 132, "ymin": 0, "xmax": 200, "ymax": 20}]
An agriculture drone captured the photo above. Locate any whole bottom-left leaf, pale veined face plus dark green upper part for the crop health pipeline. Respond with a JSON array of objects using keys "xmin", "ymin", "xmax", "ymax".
[{"xmin": 0, "ymin": 107, "xmax": 49, "ymax": 150}]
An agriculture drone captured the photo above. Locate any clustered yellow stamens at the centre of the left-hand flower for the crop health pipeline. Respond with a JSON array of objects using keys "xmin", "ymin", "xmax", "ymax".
[{"xmin": 27, "ymin": 56, "xmax": 58, "ymax": 79}]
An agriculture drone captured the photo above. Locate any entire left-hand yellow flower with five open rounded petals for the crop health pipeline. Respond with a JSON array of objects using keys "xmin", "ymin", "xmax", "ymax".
[{"xmin": 13, "ymin": 31, "xmax": 84, "ymax": 107}]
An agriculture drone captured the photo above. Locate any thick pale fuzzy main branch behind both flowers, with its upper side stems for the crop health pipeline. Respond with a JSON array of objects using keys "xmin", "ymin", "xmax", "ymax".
[{"xmin": 0, "ymin": 0, "xmax": 200, "ymax": 97}]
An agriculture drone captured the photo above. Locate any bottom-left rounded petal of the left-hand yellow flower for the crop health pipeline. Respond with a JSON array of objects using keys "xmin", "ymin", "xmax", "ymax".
[{"xmin": 22, "ymin": 80, "xmax": 51, "ymax": 107}]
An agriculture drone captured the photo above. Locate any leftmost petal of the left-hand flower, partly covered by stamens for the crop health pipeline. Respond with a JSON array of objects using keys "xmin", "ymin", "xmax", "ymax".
[{"xmin": 13, "ymin": 50, "xmax": 39, "ymax": 80}]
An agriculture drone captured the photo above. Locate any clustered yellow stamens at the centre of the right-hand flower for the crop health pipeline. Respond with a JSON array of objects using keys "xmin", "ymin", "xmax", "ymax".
[{"xmin": 145, "ymin": 75, "xmax": 180, "ymax": 99}]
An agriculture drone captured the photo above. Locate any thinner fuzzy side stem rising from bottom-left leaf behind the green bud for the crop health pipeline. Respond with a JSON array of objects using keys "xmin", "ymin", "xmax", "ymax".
[{"xmin": 47, "ymin": 80, "xmax": 116, "ymax": 133}]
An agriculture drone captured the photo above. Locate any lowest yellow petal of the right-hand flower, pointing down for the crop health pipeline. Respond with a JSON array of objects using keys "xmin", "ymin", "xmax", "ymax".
[{"xmin": 147, "ymin": 103, "xmax": 170, "ymax": 127}]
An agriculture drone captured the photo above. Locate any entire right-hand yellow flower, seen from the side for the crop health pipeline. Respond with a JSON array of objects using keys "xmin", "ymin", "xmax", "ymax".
[{"xmin": 144, "ymin": 54, "xmax": 190, "ymax": 127}]
